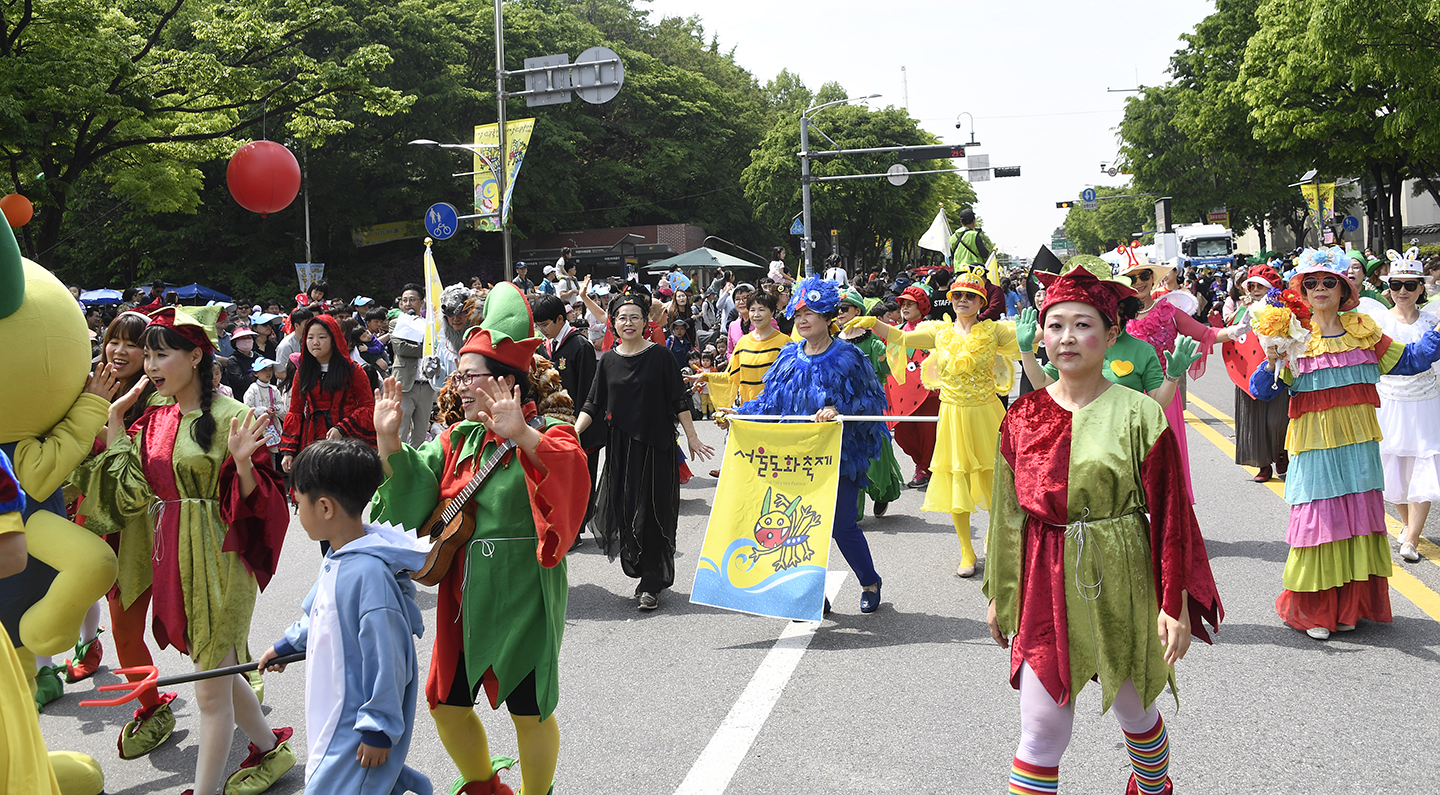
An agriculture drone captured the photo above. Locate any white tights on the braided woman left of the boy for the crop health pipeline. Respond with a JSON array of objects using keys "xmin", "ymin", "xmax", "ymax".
[{"xmin": 194, "ymin": 650, "xmax": 275, "ymax": 795}]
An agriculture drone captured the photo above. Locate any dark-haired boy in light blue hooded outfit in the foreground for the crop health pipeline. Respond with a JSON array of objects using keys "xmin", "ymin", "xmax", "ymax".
[{"xmin": 259, "ymin": 439, "xmax": 432, "ymax": 795}]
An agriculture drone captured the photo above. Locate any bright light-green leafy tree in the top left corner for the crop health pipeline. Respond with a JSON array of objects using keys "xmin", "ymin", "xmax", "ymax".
[{"xmin": 0, "ymin": 0, "xmax": 410, "ymax": 262}]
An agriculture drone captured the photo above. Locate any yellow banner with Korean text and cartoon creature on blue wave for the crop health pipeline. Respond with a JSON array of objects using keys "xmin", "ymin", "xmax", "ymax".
[{"xmin": 690, "ymin": 419, "xmax": 841, "ymax": 621}]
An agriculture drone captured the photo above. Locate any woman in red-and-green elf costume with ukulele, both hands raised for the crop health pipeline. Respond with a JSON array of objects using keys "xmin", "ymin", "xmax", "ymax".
[{"xmin": 372, "ymin": 284, "xmax": 590, "ymax": 795}]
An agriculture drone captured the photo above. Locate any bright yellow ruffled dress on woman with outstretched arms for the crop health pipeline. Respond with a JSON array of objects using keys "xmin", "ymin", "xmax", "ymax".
[{"xmin": 903, "ymin": 320, "xmax": 1020, "ymax": 513}]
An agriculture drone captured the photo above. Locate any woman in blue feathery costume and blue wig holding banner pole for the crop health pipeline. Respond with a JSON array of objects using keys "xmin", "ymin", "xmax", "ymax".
[{"xmin": 717, "ymin": 277, "xmax": 890, "ymax": 614}]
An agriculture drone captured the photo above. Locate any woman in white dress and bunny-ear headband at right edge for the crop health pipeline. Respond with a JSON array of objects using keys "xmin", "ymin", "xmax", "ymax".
[{"xmin": 1361, "ymin": 249, "xmax": 1440, "ymax": 563}]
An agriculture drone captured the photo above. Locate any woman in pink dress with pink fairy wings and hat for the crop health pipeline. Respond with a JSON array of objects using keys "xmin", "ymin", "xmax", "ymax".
[{"xmin": 1116, "ymin": 249, "xmax": 1247, "ymax": 504}]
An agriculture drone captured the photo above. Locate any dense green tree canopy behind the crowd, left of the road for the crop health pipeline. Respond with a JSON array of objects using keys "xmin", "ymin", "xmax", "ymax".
[{"xmin": 0, "ymin": 0, "xmax": 973, "ymax": 298}]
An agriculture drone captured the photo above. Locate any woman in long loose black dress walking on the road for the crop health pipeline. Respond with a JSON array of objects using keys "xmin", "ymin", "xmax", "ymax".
[{"xmin": 575, "ymin": 291, "xmax": 714, "ymax": 611}]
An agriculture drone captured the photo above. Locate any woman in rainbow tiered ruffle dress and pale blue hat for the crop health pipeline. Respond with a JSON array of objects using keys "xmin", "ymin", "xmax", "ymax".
[{"xmin": 1250, "ymin": 249, "xmax": 1440, "ymax": 641}]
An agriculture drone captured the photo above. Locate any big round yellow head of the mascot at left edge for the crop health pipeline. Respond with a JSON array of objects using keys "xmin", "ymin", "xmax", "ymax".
[{"xmin": 0, "ymin": 223, "xmax": 91, "ymax": 444}]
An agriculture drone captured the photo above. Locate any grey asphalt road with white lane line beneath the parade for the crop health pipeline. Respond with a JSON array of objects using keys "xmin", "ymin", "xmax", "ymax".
[{"xmin": 40, "ymin": 353, "xmax": 1440, "ymax": 795}]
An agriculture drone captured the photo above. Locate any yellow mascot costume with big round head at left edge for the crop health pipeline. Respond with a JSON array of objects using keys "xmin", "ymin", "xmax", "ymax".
[{"xmin": 0, "ymin": 223, "xmax": 115, "ymax": 795}]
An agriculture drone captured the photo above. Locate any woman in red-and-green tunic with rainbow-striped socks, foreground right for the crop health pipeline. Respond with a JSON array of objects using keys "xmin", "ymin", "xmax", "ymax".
[{"xmin": 984, "ymin": 268, "xmax": 1224, "ymax": 794}]
